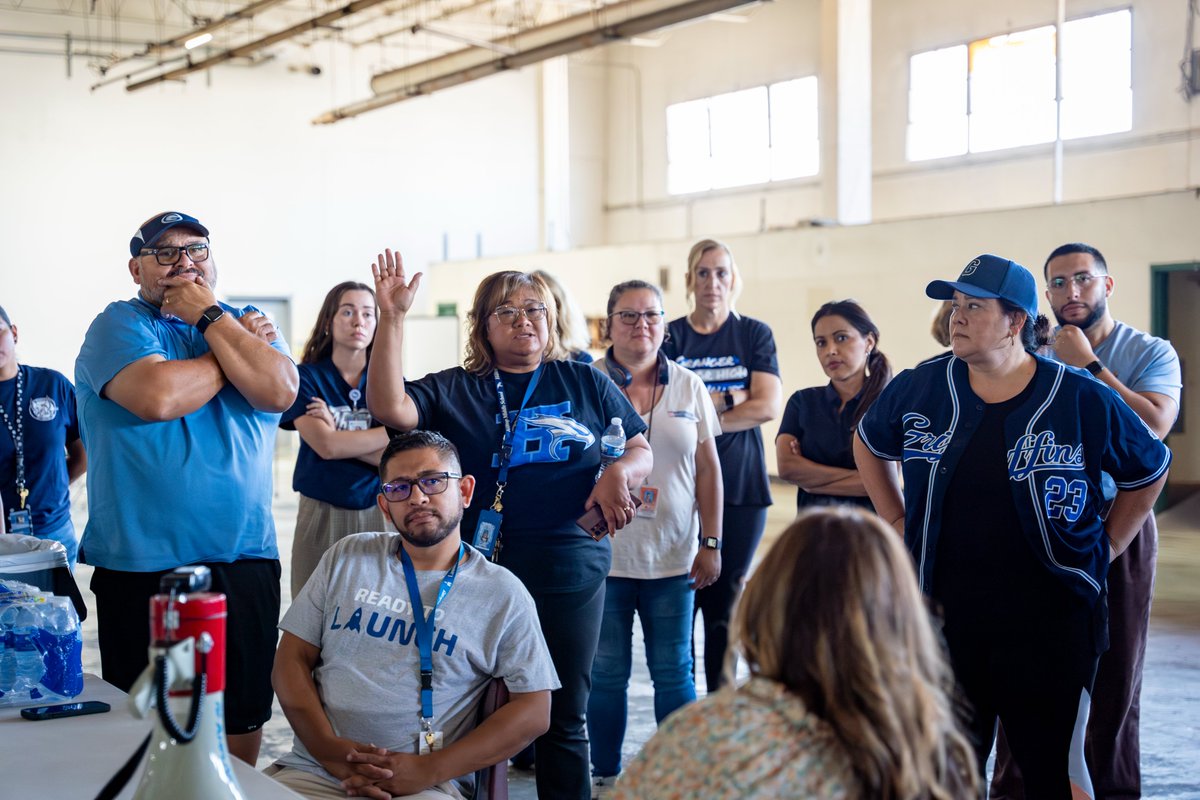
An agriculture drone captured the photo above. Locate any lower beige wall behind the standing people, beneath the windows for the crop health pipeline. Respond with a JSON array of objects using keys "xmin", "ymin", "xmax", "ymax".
[{"xmin": 424, "ymin": 192, "xmax": 1200, "ymax": 469}]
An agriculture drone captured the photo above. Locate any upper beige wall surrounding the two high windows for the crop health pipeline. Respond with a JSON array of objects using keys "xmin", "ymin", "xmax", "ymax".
[{"xmin": 595, "ymin": 0, "xmax": 1200, "ymax": 243}]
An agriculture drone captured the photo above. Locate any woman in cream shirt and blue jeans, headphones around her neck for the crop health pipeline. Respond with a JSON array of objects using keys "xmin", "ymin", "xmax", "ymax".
[{"xmin": 588, "ymin": 281, "xmax": 722, "ymax": 790}]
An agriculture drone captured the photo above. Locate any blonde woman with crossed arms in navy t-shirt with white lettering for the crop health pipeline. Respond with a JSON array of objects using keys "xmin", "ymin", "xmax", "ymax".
[{"xmin": 662, "ymin": 239, "xmax": 784, "ymax": 692}]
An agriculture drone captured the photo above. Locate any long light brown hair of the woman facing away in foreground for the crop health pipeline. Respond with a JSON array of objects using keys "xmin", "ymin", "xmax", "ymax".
[{"xmin": 727, "ymin": 506, "xmax": 979, "ymax": 800}]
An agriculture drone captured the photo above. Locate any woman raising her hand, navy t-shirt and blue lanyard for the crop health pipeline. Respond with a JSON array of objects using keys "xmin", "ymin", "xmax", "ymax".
[{"xmin": 368, "ymin": 251, "xmax": 652, "ymax": 800}]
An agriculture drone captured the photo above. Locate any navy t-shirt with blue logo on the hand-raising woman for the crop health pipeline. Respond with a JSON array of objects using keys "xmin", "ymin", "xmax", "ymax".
[{"xmin": 404, "ymin": 361, "xmax": 646, "ymax": 591}]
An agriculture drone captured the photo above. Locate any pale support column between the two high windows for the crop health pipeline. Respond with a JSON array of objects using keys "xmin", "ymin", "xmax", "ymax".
[{"xmin": 818, "ymin": 0, "xmax": 871, "ymax": 225}]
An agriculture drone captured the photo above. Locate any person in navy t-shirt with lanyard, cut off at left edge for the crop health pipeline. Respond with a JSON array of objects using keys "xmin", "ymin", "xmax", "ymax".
[{"xmin": 0, "ymin": 307, "xmax": 88, "ymax": 570}]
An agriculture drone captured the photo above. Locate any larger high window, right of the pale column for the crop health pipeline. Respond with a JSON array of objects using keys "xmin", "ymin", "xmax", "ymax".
[{"xmin": 907, "ymin": 8, "xmax": 1133, "ymax": 161}]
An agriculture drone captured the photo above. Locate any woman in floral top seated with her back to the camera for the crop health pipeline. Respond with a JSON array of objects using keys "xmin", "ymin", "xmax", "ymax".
[{"xmin": 610, "ymin": 507, "xmax": 979, "ymax": 800}]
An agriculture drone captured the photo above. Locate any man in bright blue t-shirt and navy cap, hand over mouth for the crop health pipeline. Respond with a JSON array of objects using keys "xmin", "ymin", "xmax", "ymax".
[{"xmin": 76, "ymin": 211, "xmax": 299, "ymax": 764}]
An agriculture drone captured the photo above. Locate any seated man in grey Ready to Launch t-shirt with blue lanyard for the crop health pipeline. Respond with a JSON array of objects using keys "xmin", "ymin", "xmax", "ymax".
[{"xmin": 266, "ymin": 431, "xmax": 559, "ymax": 800}]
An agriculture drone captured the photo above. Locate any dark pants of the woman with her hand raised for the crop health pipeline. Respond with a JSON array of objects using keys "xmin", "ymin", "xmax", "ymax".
[{"xmin": 518, "ymin": 576, "xmax": 605, "ymax": 800}]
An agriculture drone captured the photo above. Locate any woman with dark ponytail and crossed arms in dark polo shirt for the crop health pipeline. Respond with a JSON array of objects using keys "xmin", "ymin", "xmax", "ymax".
[{"xmin": 775, "ymin": 300, "xmax": 892, "ymax": 511}]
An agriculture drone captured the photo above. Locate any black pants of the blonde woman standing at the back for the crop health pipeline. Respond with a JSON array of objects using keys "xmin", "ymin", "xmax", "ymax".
[{"xmin": 692, "ymin": 505, "xmax": 767, "ymax": 694}]
